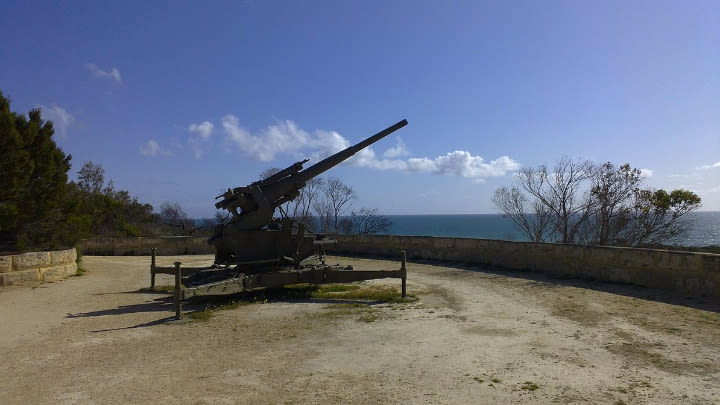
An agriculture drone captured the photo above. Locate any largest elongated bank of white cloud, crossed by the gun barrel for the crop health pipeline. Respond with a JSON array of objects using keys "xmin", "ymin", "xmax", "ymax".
[{"xmin": 222, "ymin": 114, "xmax": 520, "ymax": 182}]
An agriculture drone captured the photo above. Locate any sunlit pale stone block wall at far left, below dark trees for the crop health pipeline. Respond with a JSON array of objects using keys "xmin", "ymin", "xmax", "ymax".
[{"xmin": 0, "ymin": 248, "xmax": 77, "ymax": 285}]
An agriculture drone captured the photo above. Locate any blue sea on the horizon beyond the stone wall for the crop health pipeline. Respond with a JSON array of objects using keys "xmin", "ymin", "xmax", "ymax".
[{"xmin": 376, "ymin": 211, "xmax": 720, "ymax": 247}]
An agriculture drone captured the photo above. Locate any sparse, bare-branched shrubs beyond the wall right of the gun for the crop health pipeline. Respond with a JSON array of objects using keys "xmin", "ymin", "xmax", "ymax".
[{"xmin": 493, "ymin": 157, "xmax": 701, "ymax": 247}]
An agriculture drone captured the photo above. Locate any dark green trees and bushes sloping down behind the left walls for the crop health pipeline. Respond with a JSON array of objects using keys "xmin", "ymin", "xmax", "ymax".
[{"xmin": 0, "ymin": 92, "xmax": 208, "ymax": 252}]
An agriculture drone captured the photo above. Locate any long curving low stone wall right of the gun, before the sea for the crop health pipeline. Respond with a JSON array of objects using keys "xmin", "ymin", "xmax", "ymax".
[{"xmin": 328, "ymin": 235, "xmax": 720, "ymax": 297}]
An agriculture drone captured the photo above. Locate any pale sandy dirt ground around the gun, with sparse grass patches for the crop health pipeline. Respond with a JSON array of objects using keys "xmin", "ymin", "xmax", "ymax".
[{"xmin": 0, "ymin": 256, "xmax": 720, "ymax": 404}]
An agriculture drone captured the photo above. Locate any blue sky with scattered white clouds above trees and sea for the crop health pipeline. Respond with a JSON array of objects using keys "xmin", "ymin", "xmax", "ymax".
[{"xmin": 0, "ymin": 0, "xmax": 720, "ymax": 218}]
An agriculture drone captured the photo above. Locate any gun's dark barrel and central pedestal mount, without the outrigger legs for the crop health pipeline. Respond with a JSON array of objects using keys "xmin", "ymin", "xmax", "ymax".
[{"xmin": 209, "ymin": 120, "xmax": 407, "ymax": 268}]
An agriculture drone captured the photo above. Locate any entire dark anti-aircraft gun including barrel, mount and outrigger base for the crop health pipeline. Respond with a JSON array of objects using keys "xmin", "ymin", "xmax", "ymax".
[{"xmin": 151, "ymin": 120, "xmax": 407, "ymax": 304}]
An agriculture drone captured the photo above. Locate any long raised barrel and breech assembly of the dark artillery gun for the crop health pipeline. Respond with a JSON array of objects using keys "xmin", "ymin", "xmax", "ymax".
[{"xmin": 215, "ymin": 120, "xmax": 407, "ymax": 230}]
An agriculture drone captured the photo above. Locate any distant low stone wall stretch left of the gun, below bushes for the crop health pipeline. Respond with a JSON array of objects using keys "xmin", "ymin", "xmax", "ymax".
[{"xmin": 76, "ymin": 236, "xmax": 215, "ymax": 256}]
